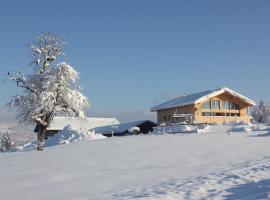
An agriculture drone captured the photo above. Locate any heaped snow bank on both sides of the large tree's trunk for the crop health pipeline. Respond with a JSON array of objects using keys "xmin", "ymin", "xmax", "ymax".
[{"xmin": 18, "ymin": 126, "xmax": 106, "ymax": 151}]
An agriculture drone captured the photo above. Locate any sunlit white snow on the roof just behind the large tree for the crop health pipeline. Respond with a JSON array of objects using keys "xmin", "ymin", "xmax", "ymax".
[{"xmin": 48, "ymin": 117, "xmax": 120, "ymax": 130}]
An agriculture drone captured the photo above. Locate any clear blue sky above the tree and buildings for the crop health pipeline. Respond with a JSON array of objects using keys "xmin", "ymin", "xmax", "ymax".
[{"xmin": 0, "ymin": 0, "xmax": 270, "ymax": 122}]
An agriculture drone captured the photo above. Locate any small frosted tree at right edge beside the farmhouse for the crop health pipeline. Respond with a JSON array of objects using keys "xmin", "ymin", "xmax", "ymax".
[{"xmin": 251, "ymin": 101, "xmax": 270, "ymax": 124}]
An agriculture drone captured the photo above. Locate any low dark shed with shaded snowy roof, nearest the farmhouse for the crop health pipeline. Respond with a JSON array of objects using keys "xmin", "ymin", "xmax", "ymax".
[{"xmin": 93, "ymin": 120, "xmax": 157, "ymax": 137}]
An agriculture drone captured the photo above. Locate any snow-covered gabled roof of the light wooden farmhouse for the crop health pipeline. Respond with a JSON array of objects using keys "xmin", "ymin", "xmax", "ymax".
[{"xmin": 151, "ymin": 87, "xmax": 256, "ymax": 112}]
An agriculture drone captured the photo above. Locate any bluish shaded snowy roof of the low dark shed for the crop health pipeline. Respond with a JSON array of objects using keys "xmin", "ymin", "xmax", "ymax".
[{"xmin": 93, "ymin": 120, "xmax": 156, "ymax": 134}]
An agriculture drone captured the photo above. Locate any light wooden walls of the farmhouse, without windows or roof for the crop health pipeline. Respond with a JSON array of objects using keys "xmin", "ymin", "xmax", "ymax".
[{"xmin": 157, "ymin": 93, "xmax": 251, "ymax": 124}]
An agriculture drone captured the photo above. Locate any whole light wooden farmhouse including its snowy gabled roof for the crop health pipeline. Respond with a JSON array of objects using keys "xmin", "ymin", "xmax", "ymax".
[{"xmin": 151, "ymin": 87, "xmax": 256, "ymax": 125}]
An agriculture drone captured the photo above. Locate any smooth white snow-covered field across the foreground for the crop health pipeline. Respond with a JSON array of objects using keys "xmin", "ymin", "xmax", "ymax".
[{"xmin": 0, "ymin": 125, "xmax": 270, "ymax": 200}]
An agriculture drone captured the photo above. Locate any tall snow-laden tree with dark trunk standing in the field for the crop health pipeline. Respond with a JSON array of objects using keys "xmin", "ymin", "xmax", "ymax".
[{"xmin": 9, "ymin": 34, "xmax": 89, "ymax": 150}]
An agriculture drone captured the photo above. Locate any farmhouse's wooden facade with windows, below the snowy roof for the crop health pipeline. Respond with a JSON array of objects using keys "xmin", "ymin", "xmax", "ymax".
[{"xmin": 153, "ymin": 88, "xmax": 254, "ymax": 124}]
